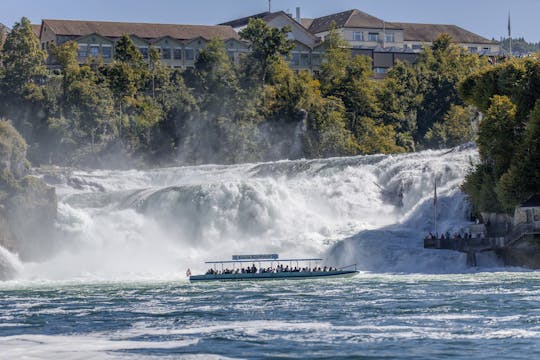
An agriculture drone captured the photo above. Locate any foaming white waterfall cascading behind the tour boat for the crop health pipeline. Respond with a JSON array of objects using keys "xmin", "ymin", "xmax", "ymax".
[{"xmin": 1, "ymin": 146, "xmax": 477, "ymax": 279}]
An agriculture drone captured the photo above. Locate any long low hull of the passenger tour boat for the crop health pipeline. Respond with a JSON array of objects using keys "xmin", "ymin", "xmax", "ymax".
[{"xmin": 189, "ymin": 270, "xmax": 358, "ymax": 281}]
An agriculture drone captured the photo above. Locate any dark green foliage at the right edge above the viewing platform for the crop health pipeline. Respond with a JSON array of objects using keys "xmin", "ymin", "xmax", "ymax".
[{"xmin": 460, "ymin": 58, "xmax": 540, "ymax": 212}]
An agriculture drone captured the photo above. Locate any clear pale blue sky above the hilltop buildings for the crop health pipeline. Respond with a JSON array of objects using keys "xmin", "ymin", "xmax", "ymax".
[{"xmin": 0, "ymin": 0, "xmax": 540, "ymax": 42}]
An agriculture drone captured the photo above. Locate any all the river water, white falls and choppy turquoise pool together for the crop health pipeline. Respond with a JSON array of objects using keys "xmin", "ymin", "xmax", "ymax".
[{"xmin": 0, "ymin": 146, "xmax": 540, "ymax": 359}]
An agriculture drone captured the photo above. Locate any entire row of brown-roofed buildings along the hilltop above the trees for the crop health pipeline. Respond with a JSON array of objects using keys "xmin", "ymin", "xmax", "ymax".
[{"xmin": 24, "ymin": 8, "xmax": 500, "ymax": 77}]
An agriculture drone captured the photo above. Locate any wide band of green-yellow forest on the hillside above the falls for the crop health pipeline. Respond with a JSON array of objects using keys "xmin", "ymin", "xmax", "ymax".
[{"xmin": 0, "ymin": 18, "xmax": 488, "ymax": 166}]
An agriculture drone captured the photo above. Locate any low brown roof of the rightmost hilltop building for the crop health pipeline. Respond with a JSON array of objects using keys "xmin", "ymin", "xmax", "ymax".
[{"xmin": 392, "ymin": 22, "xmax": 493, "ymax": 44}]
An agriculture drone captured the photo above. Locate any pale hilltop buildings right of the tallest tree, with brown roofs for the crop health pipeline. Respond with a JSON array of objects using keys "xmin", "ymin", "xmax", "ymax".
[{"xmin": 222, "ymin": 8, "xmax": 500, "ymax": 76}]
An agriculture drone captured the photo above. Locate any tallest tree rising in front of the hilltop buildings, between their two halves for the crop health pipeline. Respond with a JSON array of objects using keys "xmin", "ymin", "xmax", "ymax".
[{"xmin": 239, "ymin": 19, "xmax": 294, "ymax": 85}]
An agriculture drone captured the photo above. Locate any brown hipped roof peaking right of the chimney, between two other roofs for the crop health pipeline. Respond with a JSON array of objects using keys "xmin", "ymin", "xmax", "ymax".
[{"xmin": 309, "ymin": 9, "xmax": 401, "ymax": 34}]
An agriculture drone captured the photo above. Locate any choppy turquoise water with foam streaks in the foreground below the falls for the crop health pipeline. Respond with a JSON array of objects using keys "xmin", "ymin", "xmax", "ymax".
[{"xmin": 0, "ymin": 271, "xmax": 540, "ymax": 359}]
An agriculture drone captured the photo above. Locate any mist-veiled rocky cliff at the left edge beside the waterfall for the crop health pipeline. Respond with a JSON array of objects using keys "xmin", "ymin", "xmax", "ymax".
[{"xmin": 0, "ymin": 120, "xmax": 57, "ymax": 279}]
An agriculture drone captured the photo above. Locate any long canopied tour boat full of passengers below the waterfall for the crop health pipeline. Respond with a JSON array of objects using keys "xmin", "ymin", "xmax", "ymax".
[{"xmin": 186, "ymin": 254, "xmax": 358, "ymax": 281}]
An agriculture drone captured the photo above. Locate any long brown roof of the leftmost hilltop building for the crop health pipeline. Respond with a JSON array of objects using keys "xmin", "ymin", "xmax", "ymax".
[{"xmin": 43, "ymin": 19, "xmax": 238, "ymax": 40}]
